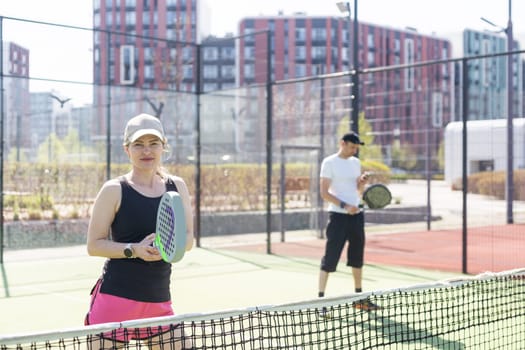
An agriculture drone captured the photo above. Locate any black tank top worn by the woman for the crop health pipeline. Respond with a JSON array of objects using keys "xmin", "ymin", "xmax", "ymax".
[{"xmin": 100, "ymin": 177, "xmax": 177, "ymax": 302}]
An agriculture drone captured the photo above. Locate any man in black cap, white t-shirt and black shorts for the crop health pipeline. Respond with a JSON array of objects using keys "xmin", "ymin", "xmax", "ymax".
[{"xmin": 319, "ymin": 132, "xmax": 378, "ymax": 310}]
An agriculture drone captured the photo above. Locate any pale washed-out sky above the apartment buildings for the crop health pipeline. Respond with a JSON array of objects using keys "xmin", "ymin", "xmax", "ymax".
[{"xmin": 0, "ymin": 0, "xmax": 525, "ymax": 104}]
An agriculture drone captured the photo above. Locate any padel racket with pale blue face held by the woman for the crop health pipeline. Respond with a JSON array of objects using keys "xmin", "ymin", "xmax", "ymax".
[{"xmin": 153, "ymin": 191, "xmax": 186, "ymax": 263}]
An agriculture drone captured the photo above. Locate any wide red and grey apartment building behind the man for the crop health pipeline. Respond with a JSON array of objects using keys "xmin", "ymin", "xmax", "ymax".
[{"xmin": 232, "ymin": 13, "xmax": 454, "ymax": 158}]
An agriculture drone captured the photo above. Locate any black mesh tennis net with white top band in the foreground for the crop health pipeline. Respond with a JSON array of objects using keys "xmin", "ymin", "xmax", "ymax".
[{"xmin": 0, "ymin": 269, "xmax": 525, "ymax": 350}]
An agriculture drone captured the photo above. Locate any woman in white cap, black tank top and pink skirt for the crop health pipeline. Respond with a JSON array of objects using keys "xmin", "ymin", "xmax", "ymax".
[{"xmin": 85, "ymin": 114, "xmax": 193, "ymax": 346}]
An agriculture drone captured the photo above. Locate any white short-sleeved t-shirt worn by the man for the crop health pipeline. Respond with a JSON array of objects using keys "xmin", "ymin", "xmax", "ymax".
[{"xmin": 321, "ymin": 153, "xmax": 361, "ymax": 213}]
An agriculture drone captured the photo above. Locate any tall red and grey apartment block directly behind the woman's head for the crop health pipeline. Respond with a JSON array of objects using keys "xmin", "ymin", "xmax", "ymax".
[{"xmin": 92, "ymin": 0, "xmax": 207, "ymax": 161}]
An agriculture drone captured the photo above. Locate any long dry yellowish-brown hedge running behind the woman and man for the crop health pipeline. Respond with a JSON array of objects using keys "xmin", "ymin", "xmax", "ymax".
[{"xmin": 4, "ymin": 161, "xmax": 402, "ymax": 220}]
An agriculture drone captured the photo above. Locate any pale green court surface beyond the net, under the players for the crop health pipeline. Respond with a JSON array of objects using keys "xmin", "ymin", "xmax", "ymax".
[{"xmin": 0, "ymin": 246, "xmax": 459, "ymax": 335}]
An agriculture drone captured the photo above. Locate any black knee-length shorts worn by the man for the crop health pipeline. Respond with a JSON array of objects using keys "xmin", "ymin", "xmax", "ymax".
[{"xmin": 321, "ymin": 212, "xmax": 365, "ymax": 272}]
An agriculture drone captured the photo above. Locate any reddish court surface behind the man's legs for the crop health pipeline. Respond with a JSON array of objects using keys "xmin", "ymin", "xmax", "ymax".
[{"xmin": 226, "ymin": 224, "xmax": 525, "ymax": 274}]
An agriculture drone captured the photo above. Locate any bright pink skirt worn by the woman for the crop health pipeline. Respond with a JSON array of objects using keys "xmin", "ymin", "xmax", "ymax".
[{"xmin": 84, "ymin": 280, "xmax": 176, "ymax": 342}]
